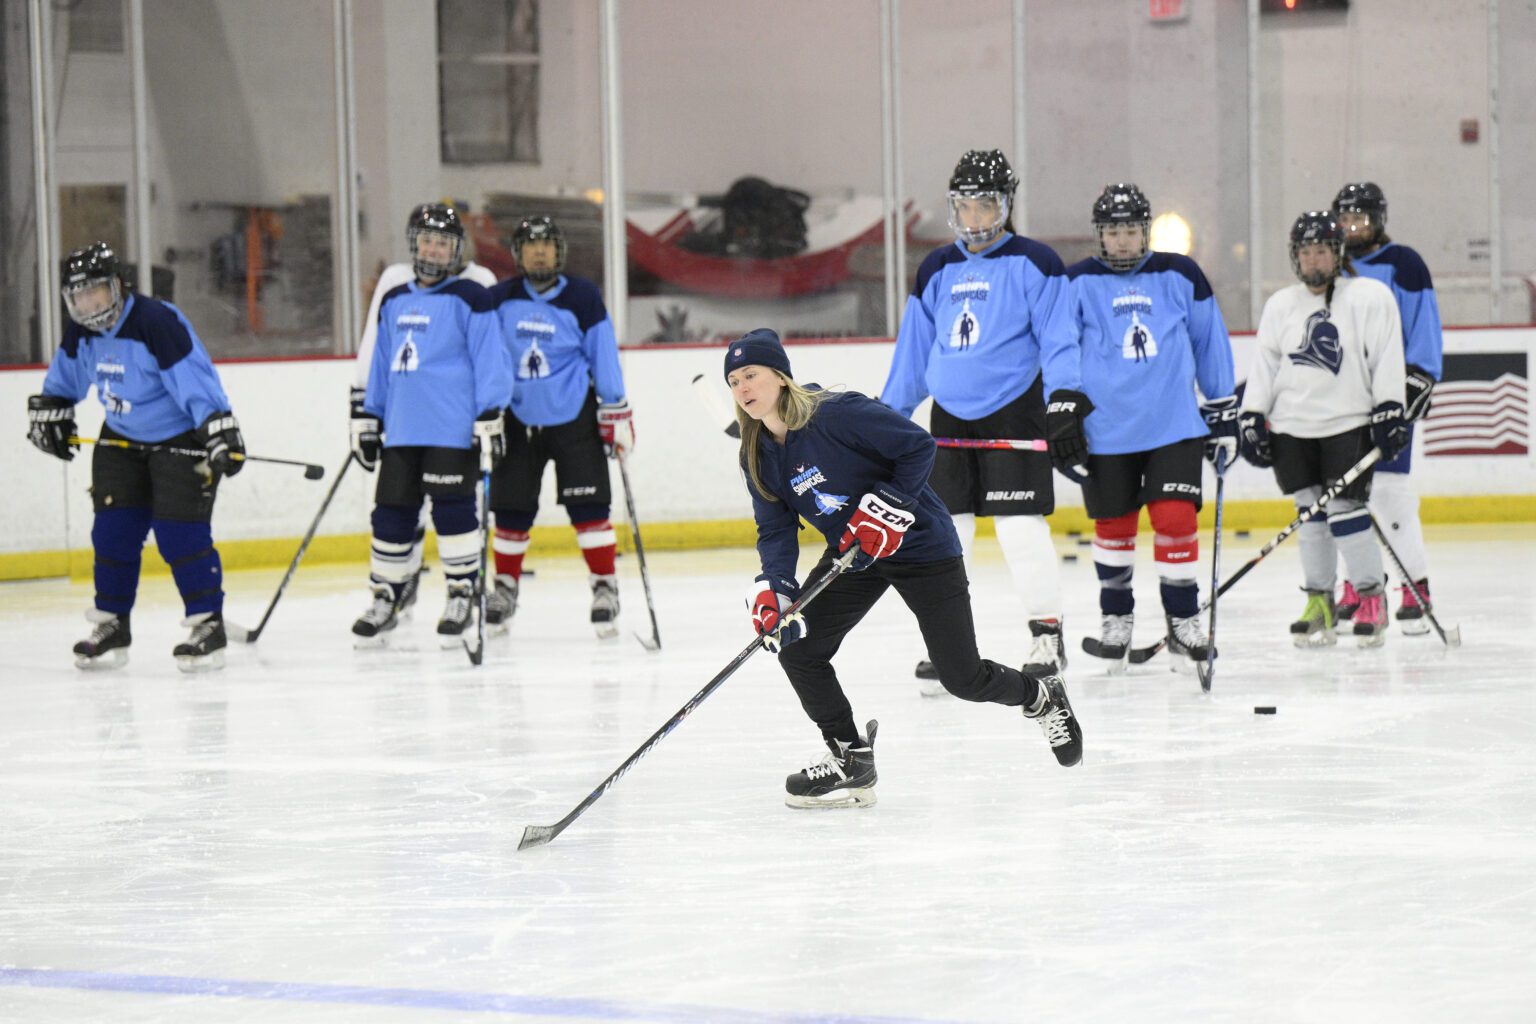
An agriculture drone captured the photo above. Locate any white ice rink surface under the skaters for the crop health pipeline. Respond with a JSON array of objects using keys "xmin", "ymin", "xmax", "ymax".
[{"xmin": 0, "ymin": 527, "xmax": 1536, "ymax": 1024}]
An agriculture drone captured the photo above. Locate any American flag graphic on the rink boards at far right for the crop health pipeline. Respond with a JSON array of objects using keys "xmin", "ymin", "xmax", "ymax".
[{"xmin": 1421, "ymin": 352, "xmax": 1530, "ymax": 456}]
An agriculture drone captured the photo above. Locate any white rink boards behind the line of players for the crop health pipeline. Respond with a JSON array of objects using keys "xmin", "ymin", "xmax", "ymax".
[{"xmin": 0, "ymin": 329, "xmax": 1536, "ymax": 564}]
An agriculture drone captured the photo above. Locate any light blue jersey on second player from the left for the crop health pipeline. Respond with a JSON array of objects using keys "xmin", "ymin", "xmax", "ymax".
[{"xmin": 362, "ymin": 276, "xmax": 511, "ymax": 448}]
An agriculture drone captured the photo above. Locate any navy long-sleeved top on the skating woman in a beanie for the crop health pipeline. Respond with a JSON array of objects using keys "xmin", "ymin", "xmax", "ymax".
[{"xmin": 746, "ymin": 391, "xmax": 960, "ymax": 580}]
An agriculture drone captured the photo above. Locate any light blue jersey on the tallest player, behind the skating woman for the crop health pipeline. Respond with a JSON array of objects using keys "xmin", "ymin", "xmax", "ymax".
[{"xmin": 880, "ymin": 232, "xmax": 1081, "ymax": 419}]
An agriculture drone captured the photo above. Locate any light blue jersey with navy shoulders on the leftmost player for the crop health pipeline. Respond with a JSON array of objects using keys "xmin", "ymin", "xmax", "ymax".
[{"xmin": 43, "ymin": 295, "xmax": 229, "ymax": 444}]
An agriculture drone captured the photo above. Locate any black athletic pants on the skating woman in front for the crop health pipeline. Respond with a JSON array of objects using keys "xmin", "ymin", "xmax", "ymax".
[{"xmin": 779, "ymin": 551, "xmax": 1035, "ymax": 743}]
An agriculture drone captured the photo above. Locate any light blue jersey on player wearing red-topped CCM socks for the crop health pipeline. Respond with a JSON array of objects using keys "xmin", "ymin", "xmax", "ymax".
[{"xmin": 1066, "ymin": 252, "xmax": 1233, "ymax": 454}]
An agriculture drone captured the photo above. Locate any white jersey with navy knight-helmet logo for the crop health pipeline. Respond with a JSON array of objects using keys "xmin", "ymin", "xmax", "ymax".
[{"xmin": 1243, "ymin": 276, "xmax": 1405, "ymax": 438}]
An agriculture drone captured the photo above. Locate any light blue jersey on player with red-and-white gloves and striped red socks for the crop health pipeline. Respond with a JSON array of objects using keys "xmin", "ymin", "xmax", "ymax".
[{"xmin": 490, "ymin": 276, "xmax": 624, "ymax": 427}]
